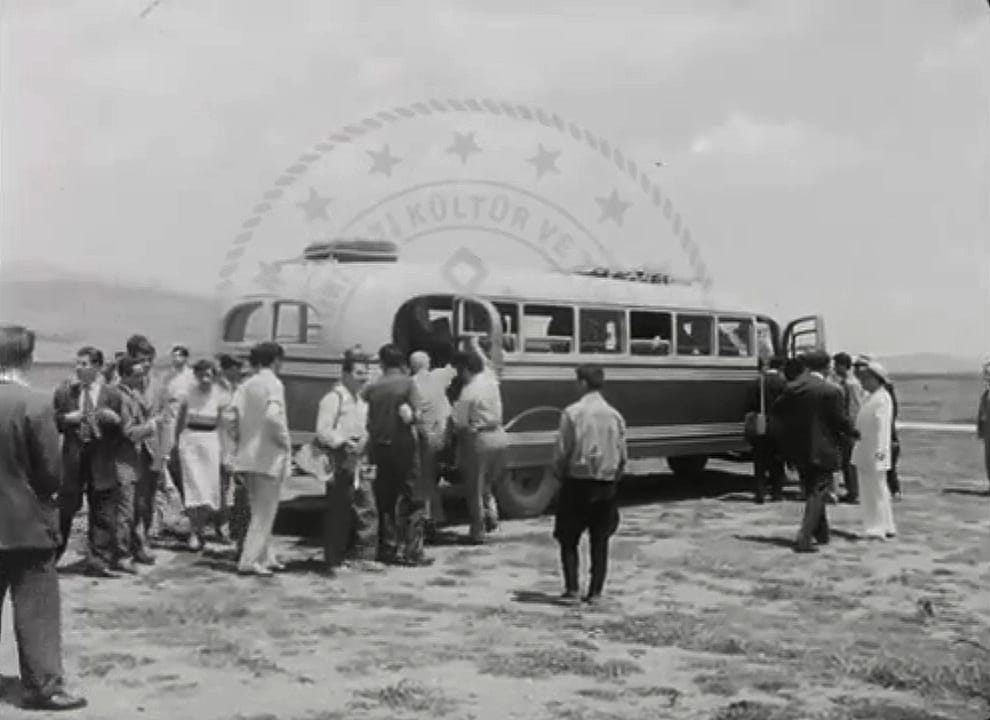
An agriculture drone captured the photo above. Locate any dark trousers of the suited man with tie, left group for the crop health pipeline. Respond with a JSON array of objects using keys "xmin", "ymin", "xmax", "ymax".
[{"xmin": 58, "ymin": 451, "xmax": 120, "ymax": 569}]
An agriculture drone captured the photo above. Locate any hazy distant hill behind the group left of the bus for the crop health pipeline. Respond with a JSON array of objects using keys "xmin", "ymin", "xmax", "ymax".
[{"xmin": 0, "ymin": 274, "xmax": 217, "ymax": 362}]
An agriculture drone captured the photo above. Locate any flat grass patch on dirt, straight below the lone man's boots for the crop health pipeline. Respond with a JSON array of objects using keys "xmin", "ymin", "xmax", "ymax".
[{"xmin": 478, "ymin": 648, "xmax": 643, "ymax": 680}]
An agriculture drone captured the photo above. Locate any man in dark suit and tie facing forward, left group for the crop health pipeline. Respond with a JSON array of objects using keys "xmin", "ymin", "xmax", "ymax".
[{"xmin": 55, "ymin": 346, "xmax": 123, "ymax": 577}]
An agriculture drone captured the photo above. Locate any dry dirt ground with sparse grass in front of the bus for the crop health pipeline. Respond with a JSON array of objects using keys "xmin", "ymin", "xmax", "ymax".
[{"xmin": 0, "ymin": 436, "xmax": 990, "ymax": 720}]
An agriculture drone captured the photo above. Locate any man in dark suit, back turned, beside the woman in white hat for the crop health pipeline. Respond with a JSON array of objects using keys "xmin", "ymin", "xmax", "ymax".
[{"xmin": 773, "ymin": 350, "xmax": 858, "ymax": 552}]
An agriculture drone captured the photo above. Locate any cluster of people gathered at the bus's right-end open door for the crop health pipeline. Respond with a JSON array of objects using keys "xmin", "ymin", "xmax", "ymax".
[{"xmin": 747, "ymin": 350, "xmax": 901, "ymax": 552}]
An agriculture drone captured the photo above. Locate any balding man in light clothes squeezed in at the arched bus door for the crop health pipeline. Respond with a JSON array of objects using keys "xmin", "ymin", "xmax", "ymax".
[{"xmin": 409, "ymin": 351, "xmax": 457, "ymax": 542}]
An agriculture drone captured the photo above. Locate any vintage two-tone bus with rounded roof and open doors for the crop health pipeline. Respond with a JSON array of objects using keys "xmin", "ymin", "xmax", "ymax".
[{"xmin": 218, "ymin": 241, "xmax": 824, "ymax": 517}]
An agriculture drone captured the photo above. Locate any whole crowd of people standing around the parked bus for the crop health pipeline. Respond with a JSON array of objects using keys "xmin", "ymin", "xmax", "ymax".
[{"xmin": 0, "ymin": 318, "xmax": 990, "ymax": 710}]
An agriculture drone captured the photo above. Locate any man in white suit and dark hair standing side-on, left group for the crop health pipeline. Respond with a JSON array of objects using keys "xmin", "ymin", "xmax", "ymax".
[{"xmin": 233, "ymin": 342, "xmax": 292, "ymax": 575}]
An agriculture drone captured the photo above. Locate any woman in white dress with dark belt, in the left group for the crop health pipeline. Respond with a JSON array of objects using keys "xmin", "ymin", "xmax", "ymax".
[{"xmin": 175, "ymin": 360, "xmax": 222, "ymax": 552}]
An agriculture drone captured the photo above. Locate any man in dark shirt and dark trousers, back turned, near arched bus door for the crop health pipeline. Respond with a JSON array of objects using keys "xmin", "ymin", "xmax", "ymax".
[{"xmin": 364, "ymin": 344, "xmax": 433, "ymax": 566}]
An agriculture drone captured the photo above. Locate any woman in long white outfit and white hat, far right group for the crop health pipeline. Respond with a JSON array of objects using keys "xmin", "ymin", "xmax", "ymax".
[{"xmin": 852, "ymin": 360, "xmax": 897, "ymax": 540}]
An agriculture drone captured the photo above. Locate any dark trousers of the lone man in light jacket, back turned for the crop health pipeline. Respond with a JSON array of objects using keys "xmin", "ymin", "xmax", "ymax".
[{"xmin": 553, "ymin": 478, "xmax": 619, "ymax": 596}]
